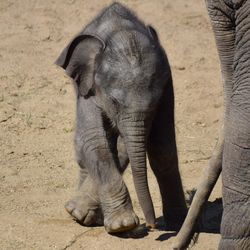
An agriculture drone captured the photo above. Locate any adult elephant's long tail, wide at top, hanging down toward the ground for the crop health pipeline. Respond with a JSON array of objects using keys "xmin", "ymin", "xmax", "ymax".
[{"xmin": 173, "ymin": 0, "xmax": 235, "ymax": 249}]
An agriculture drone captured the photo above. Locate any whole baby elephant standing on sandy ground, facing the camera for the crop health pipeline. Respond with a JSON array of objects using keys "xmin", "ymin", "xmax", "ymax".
[{"xmin": 56, "ymin": 3, "xmax": 186, "ymax": 232}]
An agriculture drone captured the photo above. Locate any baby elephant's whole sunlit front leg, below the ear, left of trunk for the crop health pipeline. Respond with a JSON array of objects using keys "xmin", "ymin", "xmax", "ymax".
[{"xmin": 66, "ymin": 97, "xmax": 138, "ymax": 232}]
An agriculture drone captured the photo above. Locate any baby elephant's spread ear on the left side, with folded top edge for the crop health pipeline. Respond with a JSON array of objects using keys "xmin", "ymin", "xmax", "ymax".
[{"xmin": 55, "ymin": 34, "xmax": 105, "ymax": 97}]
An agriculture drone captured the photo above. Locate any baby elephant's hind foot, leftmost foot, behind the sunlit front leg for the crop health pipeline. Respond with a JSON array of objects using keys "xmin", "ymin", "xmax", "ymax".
[{"xmin": 65, "ymin": 196, "xmax": 103, "ymax": 226}]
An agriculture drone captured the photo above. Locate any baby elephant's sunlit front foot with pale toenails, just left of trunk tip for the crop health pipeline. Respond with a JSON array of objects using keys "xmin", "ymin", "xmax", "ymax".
[{"xmin": 104, "ymin": 208, "xmax": 139, "ymax": 233}]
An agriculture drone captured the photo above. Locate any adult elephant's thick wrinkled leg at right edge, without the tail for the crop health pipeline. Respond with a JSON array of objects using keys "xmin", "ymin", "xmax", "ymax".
[{"xmin": 219, "ymin": 1, "xmax": 250, "ymax": 250}]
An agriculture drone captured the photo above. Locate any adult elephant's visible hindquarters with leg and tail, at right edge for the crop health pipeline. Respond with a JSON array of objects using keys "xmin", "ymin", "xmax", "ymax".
[{"xmin": 173, "ymin": 0, "xmax": 250, "ymax": 250}]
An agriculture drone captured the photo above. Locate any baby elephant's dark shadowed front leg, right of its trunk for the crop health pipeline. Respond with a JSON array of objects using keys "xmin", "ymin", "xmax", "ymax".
[{"xmin": 147, "ymin": 80, "xmax": 187, "ymax": 227}]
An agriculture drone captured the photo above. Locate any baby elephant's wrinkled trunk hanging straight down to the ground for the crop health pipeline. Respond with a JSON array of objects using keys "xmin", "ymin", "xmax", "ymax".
[{"xmin": 122, "ymin": 117, "xmax": 155, "ymax": 227}]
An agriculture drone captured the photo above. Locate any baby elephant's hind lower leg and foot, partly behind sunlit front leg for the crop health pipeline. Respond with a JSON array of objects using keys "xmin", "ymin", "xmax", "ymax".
[{"xmin": 65, "ymin": 176, "xmax": 103, "ymax": 226}]
